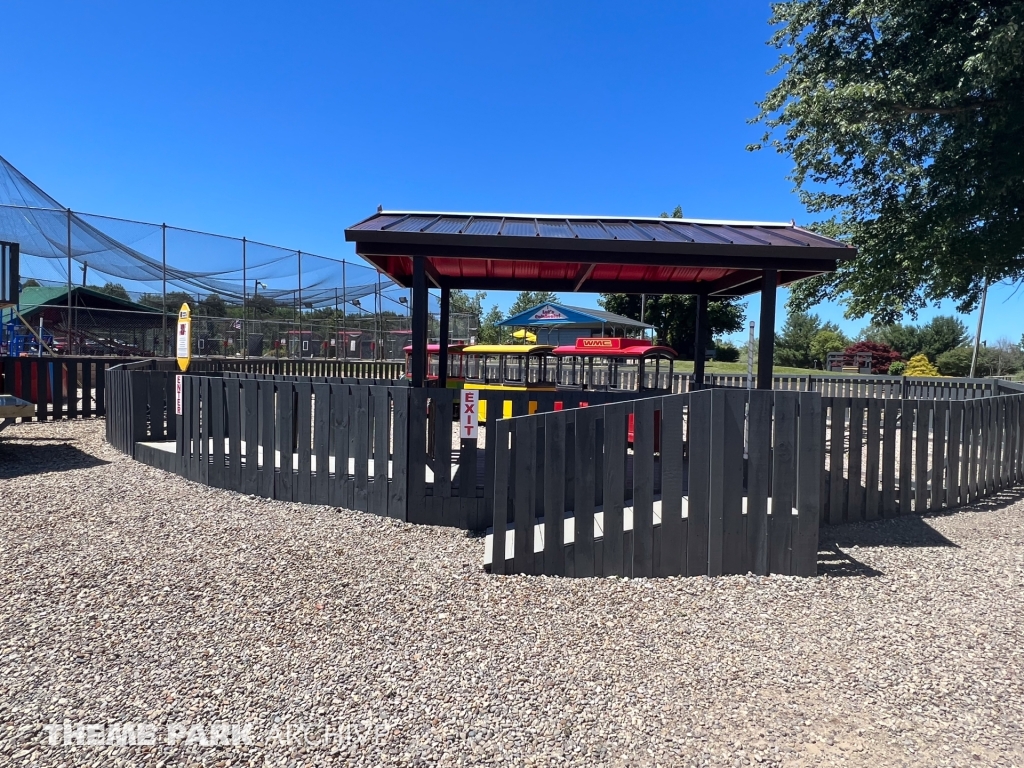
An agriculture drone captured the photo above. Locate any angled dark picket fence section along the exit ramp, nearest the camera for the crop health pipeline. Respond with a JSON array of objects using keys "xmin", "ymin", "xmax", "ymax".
[{"xmin": 489, "ymin": 389, "xmax": 821, "ymax": 577}]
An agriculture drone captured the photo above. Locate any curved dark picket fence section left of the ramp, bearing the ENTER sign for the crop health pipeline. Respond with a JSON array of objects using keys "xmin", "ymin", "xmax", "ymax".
[{"xmin": 106, "ymin": 367, "xmax": 659, "ymax": 530}]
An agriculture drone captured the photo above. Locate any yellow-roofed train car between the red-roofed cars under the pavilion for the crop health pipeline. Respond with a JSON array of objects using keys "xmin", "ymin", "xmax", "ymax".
[{"xmin": 462, "ymin": 344, "xmax": 555, "ymax": 422}]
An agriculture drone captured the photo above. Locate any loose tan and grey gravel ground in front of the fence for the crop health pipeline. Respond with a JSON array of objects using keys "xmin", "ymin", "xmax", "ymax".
[{"xmin": 0, "ymin": 422, "xmax": 1024, "ymax": 766}]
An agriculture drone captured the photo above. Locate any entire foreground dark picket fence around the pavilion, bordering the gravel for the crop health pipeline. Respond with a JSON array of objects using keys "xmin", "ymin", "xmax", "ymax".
[{"xmin": 101, "ymin": 364, "xmax": 1024, "ymax": 575}]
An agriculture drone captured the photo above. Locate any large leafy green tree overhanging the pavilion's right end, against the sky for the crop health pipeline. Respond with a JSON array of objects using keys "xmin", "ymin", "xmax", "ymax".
[{"xmin": 752, "ymin": 0, "xmax": 1024, "ymax": 324}]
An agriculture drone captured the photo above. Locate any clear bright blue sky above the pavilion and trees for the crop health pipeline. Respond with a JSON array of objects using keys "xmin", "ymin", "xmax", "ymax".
[{"xmin": 0, "ymin": 0, "xmax": 1022, "ymax": 340}]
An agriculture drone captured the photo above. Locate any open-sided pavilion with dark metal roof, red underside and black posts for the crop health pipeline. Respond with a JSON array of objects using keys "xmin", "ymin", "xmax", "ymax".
[{"xmin": 345, "ymin": 209, "xmax": 856, "ymax": 389}]
